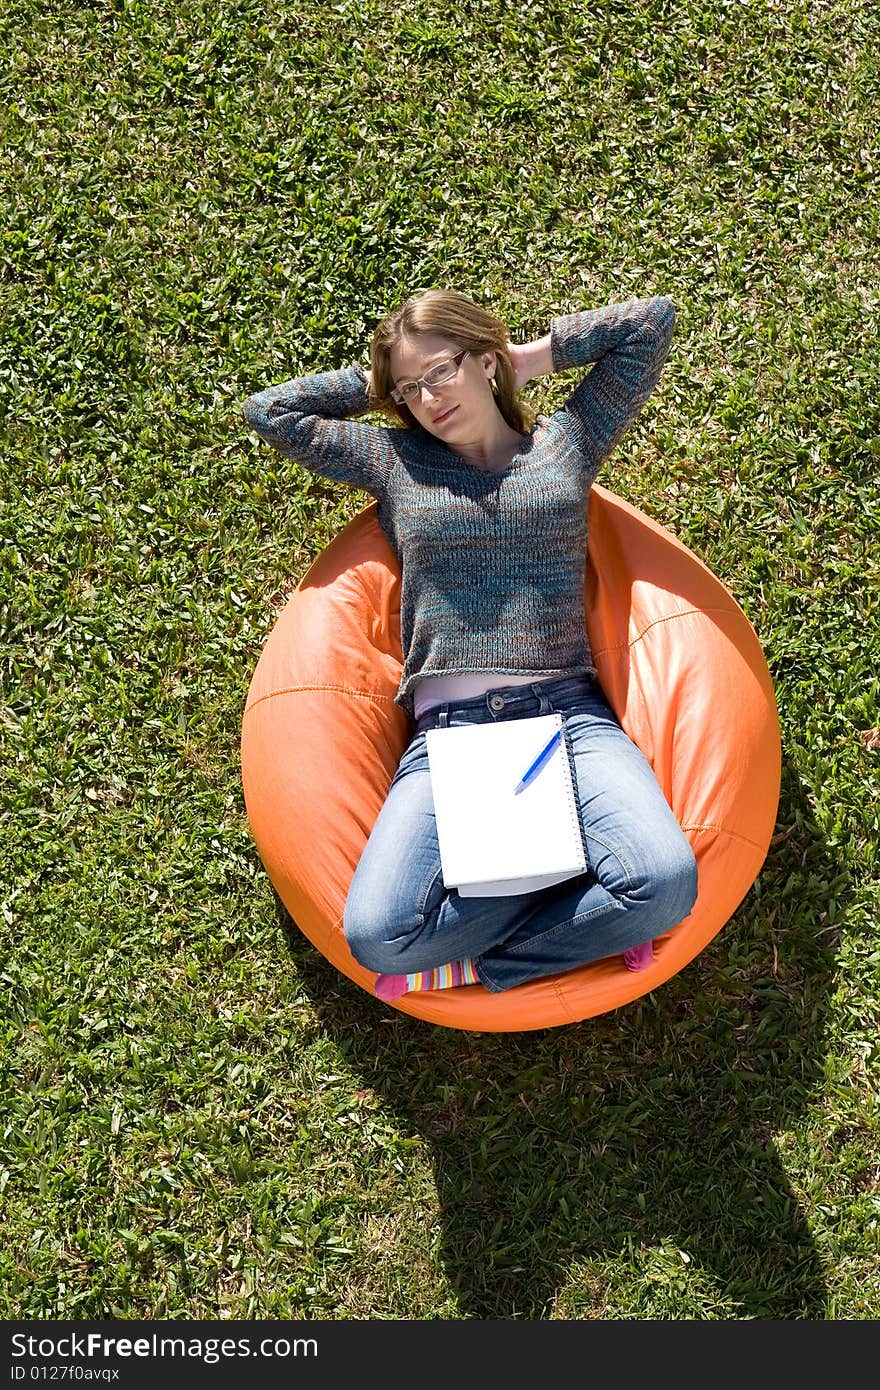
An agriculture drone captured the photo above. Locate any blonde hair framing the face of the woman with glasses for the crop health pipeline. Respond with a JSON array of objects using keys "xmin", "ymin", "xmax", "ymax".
[{"xmin": 370, "ymin": 289, "xmax": 535, "ymax": 434}]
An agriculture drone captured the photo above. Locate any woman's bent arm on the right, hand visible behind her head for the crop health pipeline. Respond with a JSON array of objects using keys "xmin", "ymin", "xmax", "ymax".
[{"xmin": 510, "ymin": 296, "xmax": 676, "ymax": 474}]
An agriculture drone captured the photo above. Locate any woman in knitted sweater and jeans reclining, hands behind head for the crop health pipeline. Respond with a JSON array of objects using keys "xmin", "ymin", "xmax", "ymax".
[{"xmin": 243, "ymin": 289, "xmax": 696, "ymax": 999}]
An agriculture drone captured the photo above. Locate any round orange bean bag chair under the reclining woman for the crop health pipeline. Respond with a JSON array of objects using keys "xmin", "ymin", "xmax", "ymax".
[{"xmin": 242, "ymin": 484, "xmax": 781, "ymax": 1031}]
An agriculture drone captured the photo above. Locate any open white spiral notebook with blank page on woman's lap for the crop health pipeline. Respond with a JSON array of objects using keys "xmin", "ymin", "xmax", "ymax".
[{"xmin": 425, "ymin": 714, "xmax": 588, "ymax": 898}]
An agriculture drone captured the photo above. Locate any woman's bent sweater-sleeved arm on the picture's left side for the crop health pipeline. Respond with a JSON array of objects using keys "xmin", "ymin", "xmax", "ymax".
[{"xmin": 242, "ymin": 366, "xmax": 393, "ymax": 496}]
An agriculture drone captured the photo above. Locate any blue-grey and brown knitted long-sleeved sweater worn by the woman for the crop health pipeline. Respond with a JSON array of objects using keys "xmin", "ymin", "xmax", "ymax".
[{"xmin": 243, "ymin": 297, "xmax": 676, "ymax": 714}]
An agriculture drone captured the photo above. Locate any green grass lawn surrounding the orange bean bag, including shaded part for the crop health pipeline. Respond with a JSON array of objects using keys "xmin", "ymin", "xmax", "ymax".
[{"xmin": 0, "ymin": 0, "xmax": 880, "ymax": 1319}]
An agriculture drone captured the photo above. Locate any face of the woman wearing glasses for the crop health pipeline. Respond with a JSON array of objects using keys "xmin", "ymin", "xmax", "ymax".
[{"xmin": 389, "ymin": 334, "xmax": 498, "ymax": 443}]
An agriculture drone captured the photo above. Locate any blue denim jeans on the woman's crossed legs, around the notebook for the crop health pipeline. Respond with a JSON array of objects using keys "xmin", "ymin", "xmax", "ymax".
[{"xmin": 343, "ymin": 677, "xmax": 696, "ymax": 992}]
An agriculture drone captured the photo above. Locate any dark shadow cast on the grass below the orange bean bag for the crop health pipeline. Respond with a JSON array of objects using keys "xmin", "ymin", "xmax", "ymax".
[{"xmin": 278, "ymin": 763, "xmax": 841, "ymax": 1319}]
